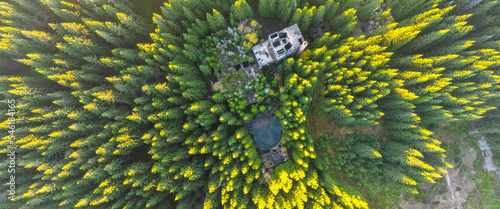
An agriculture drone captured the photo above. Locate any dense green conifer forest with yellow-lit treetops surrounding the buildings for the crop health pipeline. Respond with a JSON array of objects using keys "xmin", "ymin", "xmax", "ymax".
[{"xmin": 0, "ymin": 0, "xmax": 500, "ymax": 209}]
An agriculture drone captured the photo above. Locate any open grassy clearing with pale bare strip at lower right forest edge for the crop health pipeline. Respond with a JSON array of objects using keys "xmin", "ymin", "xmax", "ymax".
[{"xmin": 400, "ymin": 125, "xmax": 500, "ymax": 209}]
